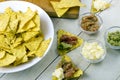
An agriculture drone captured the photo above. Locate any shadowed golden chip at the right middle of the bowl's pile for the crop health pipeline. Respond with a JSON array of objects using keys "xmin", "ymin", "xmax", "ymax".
[{"xmin": 22, "ymin": 31, "xmax": 40, "ymax": 41}]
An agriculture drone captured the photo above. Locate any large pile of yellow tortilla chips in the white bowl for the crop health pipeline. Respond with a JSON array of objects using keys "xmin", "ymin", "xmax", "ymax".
[{"xmin": 0, "ymin": 7, "xmax": 50, "ymax": 67}]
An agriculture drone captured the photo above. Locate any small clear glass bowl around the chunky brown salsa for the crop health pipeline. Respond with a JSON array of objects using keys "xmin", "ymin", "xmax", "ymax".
[{"xmin": 78, "ymin": 12, "xmax": 103, "ymax": 34}]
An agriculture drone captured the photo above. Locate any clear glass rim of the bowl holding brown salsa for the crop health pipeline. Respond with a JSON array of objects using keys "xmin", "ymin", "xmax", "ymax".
[{"xmin": 78, "ymin": 12, "xmax": 103, "ymax": 34}]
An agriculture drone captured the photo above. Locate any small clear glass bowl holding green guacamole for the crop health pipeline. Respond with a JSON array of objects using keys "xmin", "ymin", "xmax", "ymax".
[{"xmin": 104, "ymin": 26, "xmax": 120, "ymax": 49}]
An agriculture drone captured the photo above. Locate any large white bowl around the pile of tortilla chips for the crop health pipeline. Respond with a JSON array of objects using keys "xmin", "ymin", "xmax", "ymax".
[{"xmin": 0, "ymin": 1, "xmax": 54, "ymax": 73}]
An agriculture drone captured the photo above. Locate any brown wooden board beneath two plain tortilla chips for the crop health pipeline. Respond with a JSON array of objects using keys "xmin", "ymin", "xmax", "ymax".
[{"xmin": 25, "ymin": 0, "xmax": 79, "ymax": 18}]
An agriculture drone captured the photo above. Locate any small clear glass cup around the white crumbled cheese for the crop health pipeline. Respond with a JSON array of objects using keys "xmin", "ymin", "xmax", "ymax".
[{"xmin": 80, "ymin": 39, "xmax": 106, "ymax": 63}]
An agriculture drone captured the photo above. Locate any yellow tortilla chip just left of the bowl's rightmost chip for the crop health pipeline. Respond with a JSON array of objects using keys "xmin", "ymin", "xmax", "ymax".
[{"xmin": 25, "ymin": 36, "xmax": 43, "ymax": 51}]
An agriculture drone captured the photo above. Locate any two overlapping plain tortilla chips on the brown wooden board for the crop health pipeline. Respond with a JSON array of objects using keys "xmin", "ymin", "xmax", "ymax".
[{"xmin": 50, "ymin": 0, "xmax": 85, "ymax": 17}]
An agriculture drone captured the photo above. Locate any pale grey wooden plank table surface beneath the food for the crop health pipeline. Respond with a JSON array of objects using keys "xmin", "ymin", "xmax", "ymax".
[{"xmin": 0, "ymin": 0, "xmax": 120, "ymax": 80}]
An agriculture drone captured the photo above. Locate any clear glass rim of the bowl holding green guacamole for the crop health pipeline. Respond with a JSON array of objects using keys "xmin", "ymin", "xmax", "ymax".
[{"xmin": 104, "ymin": 26, "xmax": 120, "ymax": 49}]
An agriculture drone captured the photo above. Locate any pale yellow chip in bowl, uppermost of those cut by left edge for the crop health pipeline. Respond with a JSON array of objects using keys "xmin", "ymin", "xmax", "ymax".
[{"xmin": 0, "ymin": 14, "xmax": 10, "ymax": 32}]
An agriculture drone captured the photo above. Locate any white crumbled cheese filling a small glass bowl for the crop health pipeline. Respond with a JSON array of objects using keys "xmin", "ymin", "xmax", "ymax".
[{"xmin": 81, "ymin": 42, "xmax": 104, "ymax": 60}]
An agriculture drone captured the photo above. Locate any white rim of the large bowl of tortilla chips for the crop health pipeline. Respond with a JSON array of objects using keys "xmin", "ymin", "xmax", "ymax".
[{"xmin": 0, "ymin": 1, "xmax": 54, "ymax": 73}]
